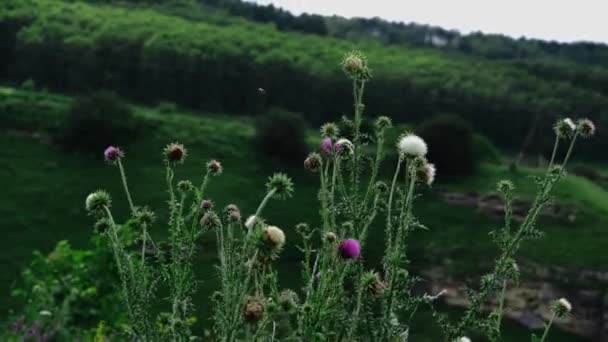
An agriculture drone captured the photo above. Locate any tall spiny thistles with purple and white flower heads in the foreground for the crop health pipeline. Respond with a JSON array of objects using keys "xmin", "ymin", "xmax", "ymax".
[{"xmin": 86, "ymin": 51, "xmax": 595, "ymax": 342}]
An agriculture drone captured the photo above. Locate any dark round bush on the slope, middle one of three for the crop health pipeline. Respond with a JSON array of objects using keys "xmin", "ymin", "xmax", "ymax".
[{"xmin": 255, "ymin": 108, "xmax": 307, "ymax": 163}]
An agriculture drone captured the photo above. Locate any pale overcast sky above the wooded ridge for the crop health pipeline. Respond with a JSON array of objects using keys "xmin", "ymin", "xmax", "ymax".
[{"xmin": 248, "ymin": 0, "xmax": 608, "ymax": 43}]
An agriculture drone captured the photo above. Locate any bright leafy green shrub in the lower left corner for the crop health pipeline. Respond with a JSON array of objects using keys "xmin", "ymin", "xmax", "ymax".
[{"xmin": 11, "ymin": 241, "xmax": 122, "ymax": 340}]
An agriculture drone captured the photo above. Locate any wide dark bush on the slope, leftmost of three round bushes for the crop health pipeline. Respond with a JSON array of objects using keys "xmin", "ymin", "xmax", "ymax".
[{"xmin": 58, "ymin": 91, "xmax": 137, "ymax": 153}]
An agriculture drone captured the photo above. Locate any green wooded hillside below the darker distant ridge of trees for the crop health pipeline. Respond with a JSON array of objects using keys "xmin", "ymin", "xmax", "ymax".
[{"xmin": 0, "ymin": 0, "xmax": 608, "ymax": 156}]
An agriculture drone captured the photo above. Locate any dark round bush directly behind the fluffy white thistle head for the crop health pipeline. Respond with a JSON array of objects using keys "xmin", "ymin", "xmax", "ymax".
[{"xmin": 417, "ymin": 115, "xmax": 478, "ymax": 176}]
